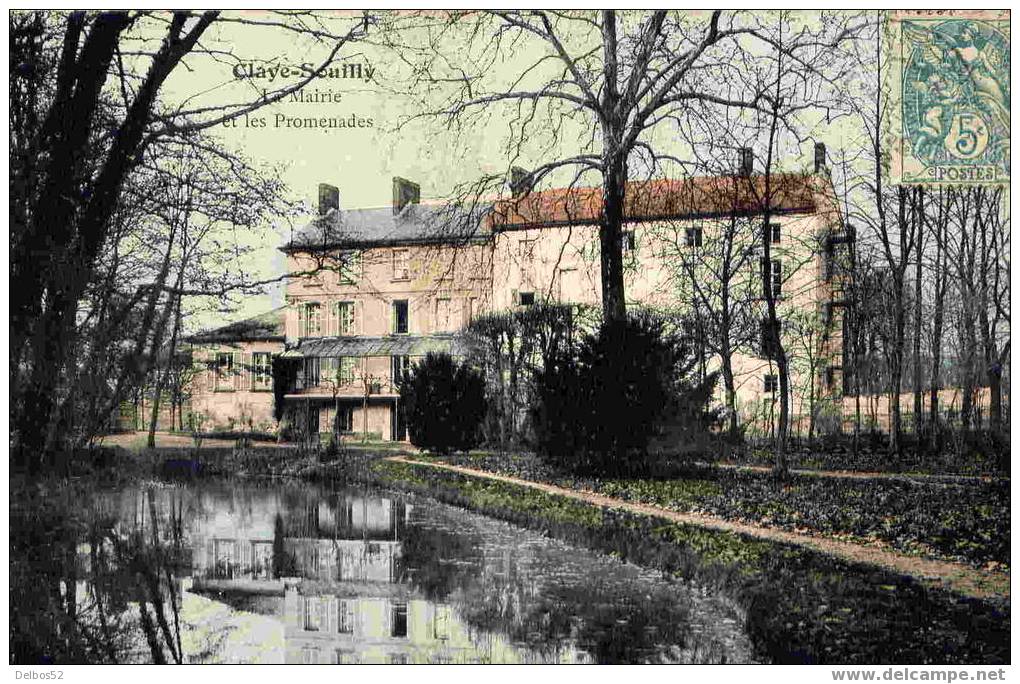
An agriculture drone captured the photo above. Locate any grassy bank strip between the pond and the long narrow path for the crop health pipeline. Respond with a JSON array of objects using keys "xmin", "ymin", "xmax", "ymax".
[{"xmin": 368, "ymin": 461, "xmax": 1010, "ymax": 664}]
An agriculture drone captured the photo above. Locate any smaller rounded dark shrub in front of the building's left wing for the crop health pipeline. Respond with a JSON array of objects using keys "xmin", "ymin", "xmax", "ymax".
[{"xmin": 400, "ymin": 354, "xmax": 486, "ymax": 453}]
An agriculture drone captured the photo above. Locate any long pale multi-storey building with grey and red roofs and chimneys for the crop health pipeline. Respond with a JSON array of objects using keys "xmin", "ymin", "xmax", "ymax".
[{"xmin": 185, "ymin": 149, "xmax": 853, "ymax": 439}]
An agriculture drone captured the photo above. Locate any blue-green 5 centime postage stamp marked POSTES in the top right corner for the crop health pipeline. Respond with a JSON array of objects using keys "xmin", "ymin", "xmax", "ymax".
[{"xmin": 884, "ymin": 10, "xmax": 1010, "ymax": 185}]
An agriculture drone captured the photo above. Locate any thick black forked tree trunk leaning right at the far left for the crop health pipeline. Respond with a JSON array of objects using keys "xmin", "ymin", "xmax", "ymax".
[{"xmin": 11, "ymin": 12, "xmax": 215, "ymax": 468}]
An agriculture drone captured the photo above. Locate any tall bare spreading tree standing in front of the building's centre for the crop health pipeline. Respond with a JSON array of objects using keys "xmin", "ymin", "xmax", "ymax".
[{"xmin": 381, "ymin": 10, "xmax": 791, "ymax": 319}]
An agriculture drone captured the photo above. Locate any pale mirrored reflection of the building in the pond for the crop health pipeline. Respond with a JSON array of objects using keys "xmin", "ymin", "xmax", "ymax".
[{"xmin": 179, "ymin": 492, "xmax": 587, "ymax": 664}]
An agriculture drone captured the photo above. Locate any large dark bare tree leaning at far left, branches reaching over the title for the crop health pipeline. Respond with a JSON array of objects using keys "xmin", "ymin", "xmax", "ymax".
[{"xmin": 10, "ymin": 11, "xmax": 367, "ymax": 468}]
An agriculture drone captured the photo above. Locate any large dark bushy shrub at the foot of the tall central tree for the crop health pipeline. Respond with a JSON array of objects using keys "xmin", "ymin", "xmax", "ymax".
[{"xmin": 531, "ymin": 312, "xmax": 716, "ymax": 474}]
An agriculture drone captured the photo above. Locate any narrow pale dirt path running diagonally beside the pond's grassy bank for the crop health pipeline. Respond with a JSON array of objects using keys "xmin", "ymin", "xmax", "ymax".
[{"xmin": 390, "ymin": 456, "xmax": 1010, "ymax": 600}]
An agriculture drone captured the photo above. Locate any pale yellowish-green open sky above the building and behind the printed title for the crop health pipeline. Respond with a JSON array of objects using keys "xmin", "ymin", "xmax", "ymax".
[{"xmin": 155, "ymin": 9, "xmax": 950, "ymax": 326}]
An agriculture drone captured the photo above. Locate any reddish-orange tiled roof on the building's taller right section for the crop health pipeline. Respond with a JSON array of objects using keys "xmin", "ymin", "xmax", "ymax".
[{"xmin": 492, "ymin": 173, "xmax": 816, "ymax": 229}]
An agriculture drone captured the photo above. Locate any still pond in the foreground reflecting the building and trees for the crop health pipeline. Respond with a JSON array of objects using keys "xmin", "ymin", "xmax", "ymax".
[{"xmin": 11, "ymin": 481, "xmax": 753, "ymax": 664}]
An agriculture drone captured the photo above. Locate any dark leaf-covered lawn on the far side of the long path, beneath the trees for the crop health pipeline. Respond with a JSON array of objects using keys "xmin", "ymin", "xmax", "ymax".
[{"xmin": 410, "ymin": 453, "xmax": 1010, "ymax": 570}]
